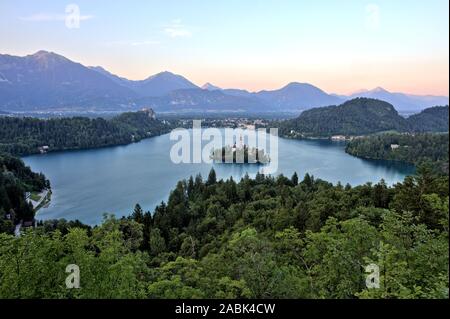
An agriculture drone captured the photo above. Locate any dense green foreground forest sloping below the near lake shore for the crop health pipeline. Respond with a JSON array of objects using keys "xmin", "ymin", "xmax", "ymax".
[{"xmin": 0, "ymin": 164, "xmax": 449, "ymax": 299}]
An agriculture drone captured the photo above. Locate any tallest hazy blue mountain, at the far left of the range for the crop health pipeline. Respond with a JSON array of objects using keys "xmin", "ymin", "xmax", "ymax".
[{"xmin": 0, "ymin": 50, "xmax": 136, "ymax": 110}]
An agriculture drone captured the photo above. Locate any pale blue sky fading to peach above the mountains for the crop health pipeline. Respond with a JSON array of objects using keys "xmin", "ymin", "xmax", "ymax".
[{"xmin": 0, "ymin": 0, "xmax": 449, "ymax": 96}]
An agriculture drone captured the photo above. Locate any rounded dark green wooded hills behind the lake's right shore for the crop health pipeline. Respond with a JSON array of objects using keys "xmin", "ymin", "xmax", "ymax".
[{"xmin": 279, "ymin": 98, "xmax": 448, "ymax": 138}]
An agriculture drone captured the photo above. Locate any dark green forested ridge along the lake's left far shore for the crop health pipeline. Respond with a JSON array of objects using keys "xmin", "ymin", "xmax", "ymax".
[{"xmin": 0, "ymin": 110, "xmax": 174, "ymax": 156}]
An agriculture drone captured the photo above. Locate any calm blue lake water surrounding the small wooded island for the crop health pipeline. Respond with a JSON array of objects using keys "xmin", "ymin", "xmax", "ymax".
[{"xmin": 23, "ymin": 134, "xmax": 414, "ymax": 225}]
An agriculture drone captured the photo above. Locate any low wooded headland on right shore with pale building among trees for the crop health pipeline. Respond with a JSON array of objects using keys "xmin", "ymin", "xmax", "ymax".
[{"xmin": 346, "ymin": 133, "xmax": 449, "ymax": 174}]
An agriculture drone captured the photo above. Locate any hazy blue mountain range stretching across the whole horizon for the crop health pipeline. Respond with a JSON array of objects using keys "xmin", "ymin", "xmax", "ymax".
[{"xmin": 0, "ymin": 51, "xmax": 449, "ymax": 113}]
